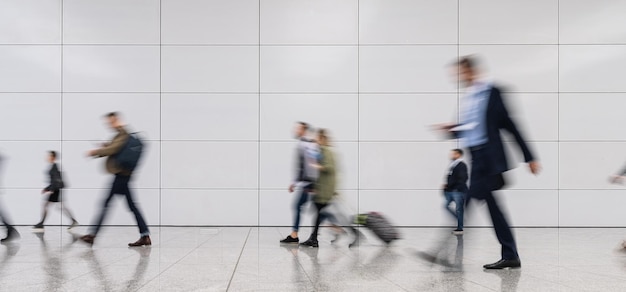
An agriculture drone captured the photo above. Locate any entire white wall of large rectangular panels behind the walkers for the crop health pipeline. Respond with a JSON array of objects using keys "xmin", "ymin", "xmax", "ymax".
[{"xmin": 0, "ymin": 0, "xmax": 626, "ymax": 226}]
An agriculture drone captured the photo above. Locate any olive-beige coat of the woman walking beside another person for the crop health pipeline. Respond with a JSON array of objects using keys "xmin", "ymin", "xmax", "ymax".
[{"xmin": 313, "ymin": 146, "xmax": 337, "ymax": 204}]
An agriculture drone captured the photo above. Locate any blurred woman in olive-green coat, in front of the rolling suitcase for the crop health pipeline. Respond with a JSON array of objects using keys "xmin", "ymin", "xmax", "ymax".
[{"xmin": 301, "ymin": 129, "xmax": 337, "ymax": 247}]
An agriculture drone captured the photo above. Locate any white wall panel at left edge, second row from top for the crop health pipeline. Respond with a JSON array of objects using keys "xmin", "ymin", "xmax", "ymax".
[{"xmin": 0, "ymin": 45, "xmax": 61, "ymax": 92}]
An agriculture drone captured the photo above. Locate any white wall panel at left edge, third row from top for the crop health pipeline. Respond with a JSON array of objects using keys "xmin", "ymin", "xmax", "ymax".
[{"xmin": 0, "ymin": 93, "xmax": 61, "ymax": 140}]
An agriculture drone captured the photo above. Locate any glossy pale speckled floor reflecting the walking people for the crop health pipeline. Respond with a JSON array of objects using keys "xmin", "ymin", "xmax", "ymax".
[{"xmin": 0, "ymin": 227, "xmax": 626, "ymax": 291}]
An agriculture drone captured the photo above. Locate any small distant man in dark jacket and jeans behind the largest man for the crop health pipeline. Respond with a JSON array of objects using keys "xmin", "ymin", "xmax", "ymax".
[{"xmin": 443, "ymin": 149, "xmax": 468, "ymax": 235}]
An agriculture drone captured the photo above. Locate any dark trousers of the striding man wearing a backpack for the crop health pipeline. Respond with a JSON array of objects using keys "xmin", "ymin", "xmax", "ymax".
[{"xmin": 91, "ymin": 174, "xmax": 150, "ymax": 236}]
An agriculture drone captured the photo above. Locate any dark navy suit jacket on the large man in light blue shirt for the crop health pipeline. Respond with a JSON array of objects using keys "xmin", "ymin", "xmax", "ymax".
[{"xmin": 455, "ymin": 86, "xmax": 535, "ymax": 175}]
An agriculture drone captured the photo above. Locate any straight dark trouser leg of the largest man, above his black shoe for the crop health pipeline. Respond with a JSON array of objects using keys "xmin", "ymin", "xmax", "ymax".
[{"xmin": 486, "ymin": 194, "xmax": 519, "ymax": 260}]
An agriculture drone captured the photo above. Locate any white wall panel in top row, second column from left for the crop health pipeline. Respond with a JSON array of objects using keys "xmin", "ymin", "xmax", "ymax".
[{"xmin": 63, "ymin": 0, "xmax": 160, "ymax": 44}]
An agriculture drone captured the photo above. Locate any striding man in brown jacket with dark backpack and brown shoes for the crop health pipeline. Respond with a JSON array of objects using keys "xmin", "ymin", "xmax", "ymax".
[{"xmin": 81, "ymin": 112, "xmax": 152, "ymax": 246}]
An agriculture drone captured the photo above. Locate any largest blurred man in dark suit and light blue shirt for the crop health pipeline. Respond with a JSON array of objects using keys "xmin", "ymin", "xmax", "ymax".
[{"xmin": 438, "ymin": 57, "xmax": 540, "ymax": 269}]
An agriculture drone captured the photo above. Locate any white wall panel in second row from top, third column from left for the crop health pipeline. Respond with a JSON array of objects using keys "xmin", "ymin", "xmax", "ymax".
[{"xmin": 161, "ymin": 46, "xmax": 259, "ymax": 92}]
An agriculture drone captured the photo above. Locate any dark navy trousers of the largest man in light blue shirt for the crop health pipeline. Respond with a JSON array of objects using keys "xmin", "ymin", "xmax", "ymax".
[{"xmin": 466, "ymin": 148, "xmax": 519, "ymax": 260}]
